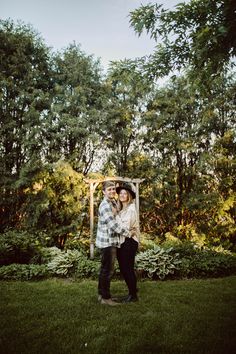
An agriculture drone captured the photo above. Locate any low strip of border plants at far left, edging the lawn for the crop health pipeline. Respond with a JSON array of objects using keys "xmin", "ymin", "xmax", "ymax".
[{"xmin": 0, "ymin": 264, "xmax": 48, "ymax": 280}]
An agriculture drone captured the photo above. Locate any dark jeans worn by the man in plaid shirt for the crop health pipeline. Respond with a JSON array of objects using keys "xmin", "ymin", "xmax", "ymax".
[{"xmin": 98, "ymin": 246, "xmax": 116, "ymax": 299}]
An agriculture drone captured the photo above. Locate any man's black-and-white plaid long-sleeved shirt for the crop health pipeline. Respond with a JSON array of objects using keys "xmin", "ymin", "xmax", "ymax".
[{"xmin": 96, "ymin": 198, "xmax": 129, "ymax": 248}]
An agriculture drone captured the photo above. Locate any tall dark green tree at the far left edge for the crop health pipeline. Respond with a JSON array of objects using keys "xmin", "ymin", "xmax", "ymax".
[{"xmin": 0, "ymin": 21, "xmax": 52, "ymax": 230}]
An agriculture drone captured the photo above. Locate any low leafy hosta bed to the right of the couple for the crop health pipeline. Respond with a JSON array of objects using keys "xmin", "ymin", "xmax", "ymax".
[{"xmin": 136, "ymin": 239, "xmax": 236, "ymax": 279}]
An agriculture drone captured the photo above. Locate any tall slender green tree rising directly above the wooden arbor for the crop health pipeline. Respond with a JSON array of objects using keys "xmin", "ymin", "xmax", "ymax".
[{"xmin": 100, "ymin": 60, "xmax": 151, "ymax": 176}]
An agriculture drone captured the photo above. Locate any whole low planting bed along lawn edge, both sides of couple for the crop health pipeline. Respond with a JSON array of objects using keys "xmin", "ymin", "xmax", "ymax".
[{"xmin": 0, "ymin": 231, "xmax": 236, "ymax": 280}]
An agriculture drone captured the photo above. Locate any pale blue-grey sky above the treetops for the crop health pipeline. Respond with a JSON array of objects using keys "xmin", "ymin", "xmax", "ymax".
[{"xmin": 0, "ymin": 0, "xmax": 181, "ymax": 70}]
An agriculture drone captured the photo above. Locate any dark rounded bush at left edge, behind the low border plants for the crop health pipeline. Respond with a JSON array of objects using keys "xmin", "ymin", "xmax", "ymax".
[{"xmin": 0, "ymin": 230, "xmax": 42, "ymax": 265}]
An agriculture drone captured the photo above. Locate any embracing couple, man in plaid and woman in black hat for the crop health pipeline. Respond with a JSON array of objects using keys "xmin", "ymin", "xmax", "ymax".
[{"xmin": 96, "ymin": 181, "xmax": 138, "ymax": 306}]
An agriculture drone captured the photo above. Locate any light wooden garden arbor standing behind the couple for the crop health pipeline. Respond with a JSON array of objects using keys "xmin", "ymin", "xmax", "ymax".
[{"xmin": 85, "ymin": 177, "xmax": 144, "ymax": 258}]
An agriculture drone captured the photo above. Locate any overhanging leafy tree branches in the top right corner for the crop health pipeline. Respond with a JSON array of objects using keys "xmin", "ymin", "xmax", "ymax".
[{"xmin": 130, "ymin": 0, "xmax": 236, "ymax": 77}]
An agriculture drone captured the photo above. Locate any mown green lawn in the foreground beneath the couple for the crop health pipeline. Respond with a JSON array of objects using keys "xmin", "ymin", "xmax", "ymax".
[{"xmin": 0, "ymin": 276, "xmax": 236, "ymax": 354}]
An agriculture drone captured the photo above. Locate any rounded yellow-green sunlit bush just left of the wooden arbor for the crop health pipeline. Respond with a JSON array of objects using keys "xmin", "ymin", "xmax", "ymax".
[{"xmin": 22, "ymin": 161, "xmax": 88, "ymax": 247}]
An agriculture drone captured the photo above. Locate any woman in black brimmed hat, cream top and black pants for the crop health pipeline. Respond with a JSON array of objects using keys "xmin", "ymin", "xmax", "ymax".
[{"xmin": 116, "ymin": 183, "xmax": 139, "ymax": 302}]
